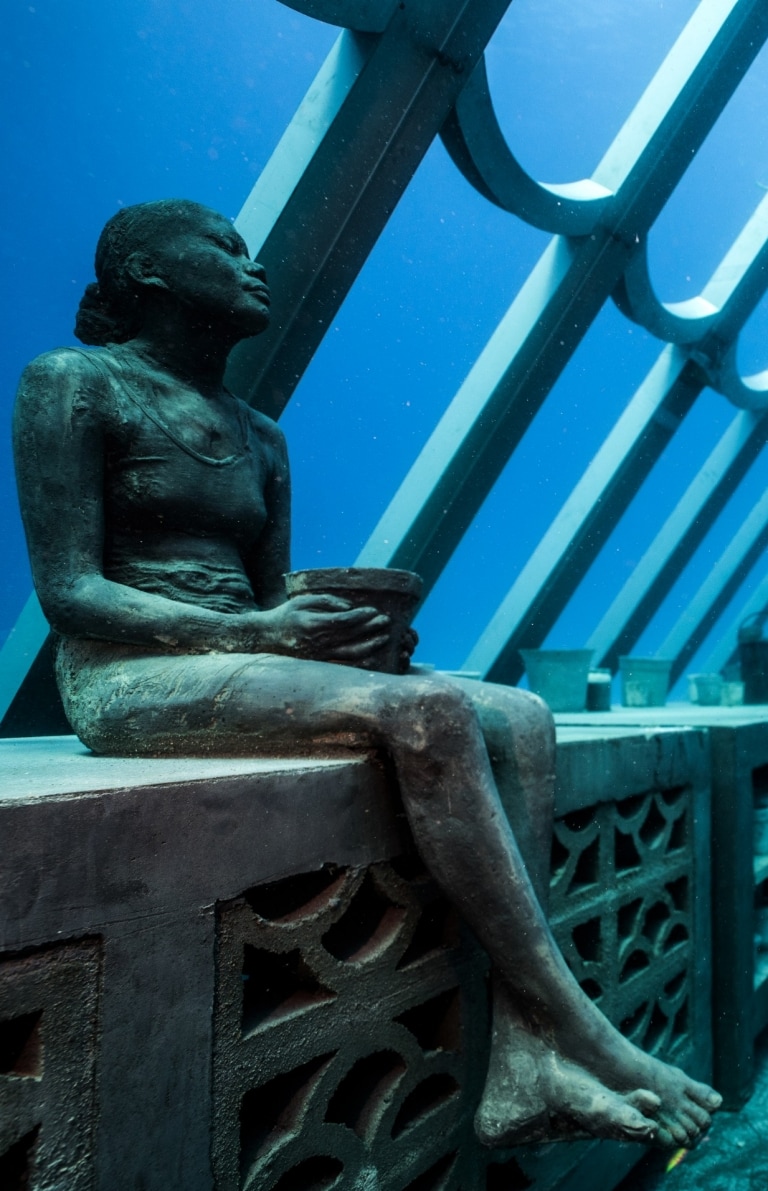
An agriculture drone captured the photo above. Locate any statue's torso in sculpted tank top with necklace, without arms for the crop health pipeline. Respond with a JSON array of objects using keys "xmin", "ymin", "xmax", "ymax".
[{"xmin": 82, "ymin": 351, "xmax": 274, "ymax": 612}]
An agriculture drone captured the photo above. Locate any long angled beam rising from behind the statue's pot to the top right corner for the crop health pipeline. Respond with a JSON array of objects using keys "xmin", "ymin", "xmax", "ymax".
[{"xmin": 357, "ymin": 0, "xmax": 768, "ymax": 593}]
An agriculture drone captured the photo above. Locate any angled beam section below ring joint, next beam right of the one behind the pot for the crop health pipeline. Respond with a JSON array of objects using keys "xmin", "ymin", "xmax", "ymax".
[{"xmin": 463, "ymin": 347, "xmax": 704, "ymax": 684}]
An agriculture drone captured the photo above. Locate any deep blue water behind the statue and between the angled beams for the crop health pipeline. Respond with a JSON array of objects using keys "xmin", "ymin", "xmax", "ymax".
[{"xmin": 0, "ymin": 0, "xmax": 768, "ymax": 700}]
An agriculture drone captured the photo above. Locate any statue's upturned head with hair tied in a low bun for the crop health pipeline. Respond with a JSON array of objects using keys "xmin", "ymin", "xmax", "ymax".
[{"xmin": 75, "ymin": 199, "xmax": 269, "ymax": 347}]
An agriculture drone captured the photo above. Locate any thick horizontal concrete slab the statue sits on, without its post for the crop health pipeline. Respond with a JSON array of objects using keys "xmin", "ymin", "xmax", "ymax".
[{"xmin": 0, "ymin": 736, "xmax": 401, "ymax": 950}]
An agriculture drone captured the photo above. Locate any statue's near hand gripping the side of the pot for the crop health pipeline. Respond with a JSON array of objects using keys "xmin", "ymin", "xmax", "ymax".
[{"xmin": 255, "ymin": 596, "xmax": 389, "ymax": 666}]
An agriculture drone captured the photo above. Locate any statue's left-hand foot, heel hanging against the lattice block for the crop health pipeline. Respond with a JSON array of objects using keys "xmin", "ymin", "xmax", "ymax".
[{"xmin": 475, "ymin": 1025, "xmax": 661, "ymax": 1146}]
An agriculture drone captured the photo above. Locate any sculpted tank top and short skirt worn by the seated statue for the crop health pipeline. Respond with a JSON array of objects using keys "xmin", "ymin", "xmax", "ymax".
[{"xmin": 56, "ymin": 348, "xmax": 431, "ymax": 756}]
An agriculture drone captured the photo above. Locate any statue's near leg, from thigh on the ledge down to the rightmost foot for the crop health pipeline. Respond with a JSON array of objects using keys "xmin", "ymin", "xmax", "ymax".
[{"xmin": 59, "ymin": 654, "xmax": 719, "ymax": 1145}]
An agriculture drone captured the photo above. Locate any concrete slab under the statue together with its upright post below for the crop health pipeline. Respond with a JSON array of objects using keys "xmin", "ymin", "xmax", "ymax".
[{"xmin": 0, "ymin": 737, "xmax": 400, "ymax": 1191}]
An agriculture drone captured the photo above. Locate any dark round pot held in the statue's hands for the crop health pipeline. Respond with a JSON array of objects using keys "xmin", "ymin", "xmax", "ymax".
[{"xmin": 285, "ymin": 567, "xmax": 423, "ymax": 674}]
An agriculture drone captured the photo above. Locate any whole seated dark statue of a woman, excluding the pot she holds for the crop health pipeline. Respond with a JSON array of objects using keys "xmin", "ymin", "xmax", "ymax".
[{"xmin": 14, "ymin": 200, "xmax": 720, "ymax": 1147}]
